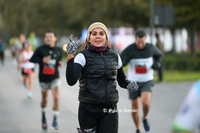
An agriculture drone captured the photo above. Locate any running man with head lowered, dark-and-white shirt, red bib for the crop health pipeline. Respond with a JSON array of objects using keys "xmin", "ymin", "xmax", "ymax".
[{"xmin": 121, "ymin": 31, "xmax": 162, "ymax": 133}]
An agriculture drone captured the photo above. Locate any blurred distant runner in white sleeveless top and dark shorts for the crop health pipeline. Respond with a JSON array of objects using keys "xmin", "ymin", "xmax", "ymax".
[{"xmin": 19, "ymin": 42, "xmax": 35, "ymax": 98}]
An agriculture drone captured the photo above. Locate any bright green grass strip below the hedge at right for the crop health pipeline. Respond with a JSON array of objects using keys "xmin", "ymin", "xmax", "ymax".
[{"xmin": 124, "ymin": 65, "xmax": 200, "ymax": 82}]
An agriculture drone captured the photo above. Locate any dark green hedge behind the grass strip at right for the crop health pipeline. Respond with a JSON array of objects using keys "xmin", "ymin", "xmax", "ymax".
[{"xmin": 164, "ymin": 52, "xmax": 200, "ymax": 71}]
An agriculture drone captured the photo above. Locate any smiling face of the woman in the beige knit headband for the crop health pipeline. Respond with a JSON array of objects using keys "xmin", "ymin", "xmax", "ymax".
[{"xmin": 90, "ymin": 28, "xmax": 107, "ymax": 47}]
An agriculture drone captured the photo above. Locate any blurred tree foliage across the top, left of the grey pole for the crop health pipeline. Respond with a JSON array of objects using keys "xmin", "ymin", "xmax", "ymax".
[{"xmin": 0, "ymin": 0, "xmax": 149, "ymax": 41}]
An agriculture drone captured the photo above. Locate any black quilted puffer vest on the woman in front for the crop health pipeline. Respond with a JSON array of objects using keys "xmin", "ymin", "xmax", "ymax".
[{"xmin": 79, "ymin": 47, "xmax": 119, "ymax": 105}]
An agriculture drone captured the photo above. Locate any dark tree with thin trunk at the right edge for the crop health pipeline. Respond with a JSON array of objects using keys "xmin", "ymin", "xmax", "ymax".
[{"xmin": 169, "ymin": 0, "xmax": 200, "ymax": 57}]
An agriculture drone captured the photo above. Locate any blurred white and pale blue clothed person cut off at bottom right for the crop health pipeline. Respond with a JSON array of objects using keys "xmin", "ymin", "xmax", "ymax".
[{"xmin": 172, "ymin": 80, "xmax": 200, "ymax": 133}]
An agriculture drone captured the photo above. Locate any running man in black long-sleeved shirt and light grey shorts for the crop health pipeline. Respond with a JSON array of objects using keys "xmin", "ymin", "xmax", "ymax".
[{"xmin": 30, "ymin": 31, "xmax": 62, "ymax": 130}]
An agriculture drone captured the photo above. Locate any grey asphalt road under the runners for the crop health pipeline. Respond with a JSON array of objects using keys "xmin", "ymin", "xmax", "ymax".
[{"xmin": 0, "ymin": 51, "xmax": 192, "ymax": 133}]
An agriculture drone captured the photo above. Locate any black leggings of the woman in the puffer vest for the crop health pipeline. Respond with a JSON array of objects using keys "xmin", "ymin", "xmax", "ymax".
[{"xmin": 78, "ymin": 106, "xmax": 118, "ymax": 133}]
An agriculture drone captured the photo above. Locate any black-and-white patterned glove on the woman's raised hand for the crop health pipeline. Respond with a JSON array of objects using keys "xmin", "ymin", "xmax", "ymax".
[{"xmin": 66, "ymin": 34, "xmax": 80, "ymax": 54}]
